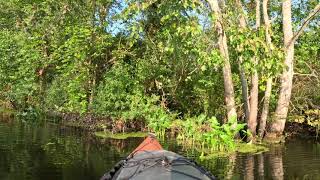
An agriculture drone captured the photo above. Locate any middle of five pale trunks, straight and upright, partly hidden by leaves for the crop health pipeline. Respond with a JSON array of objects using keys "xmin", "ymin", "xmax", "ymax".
[{"xmin": 248, "ymin": 0, "xmax": 260, "ymax": 137}]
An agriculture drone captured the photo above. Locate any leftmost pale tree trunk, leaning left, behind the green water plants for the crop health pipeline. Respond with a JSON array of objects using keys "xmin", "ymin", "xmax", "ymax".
[{"xmin": 208, "ymin": 0, "xmax": 237, "ymax": 120}]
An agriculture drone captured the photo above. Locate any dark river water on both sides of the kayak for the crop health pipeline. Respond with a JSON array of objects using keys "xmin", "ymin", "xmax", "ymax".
[{"xmin": 0, "ymin": 117, "xmax": 320, "ymax": 180}]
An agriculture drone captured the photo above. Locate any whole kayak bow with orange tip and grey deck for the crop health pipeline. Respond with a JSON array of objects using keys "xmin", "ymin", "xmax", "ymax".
[{"xmin": 101, "ymin": 135, "xmax": 215, "ymax": 180}]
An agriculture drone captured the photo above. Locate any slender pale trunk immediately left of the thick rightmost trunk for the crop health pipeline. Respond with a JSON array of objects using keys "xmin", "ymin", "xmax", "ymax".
[{"xmin": 258, "ymin": 0, "xmax": 272, "ymax": 138}]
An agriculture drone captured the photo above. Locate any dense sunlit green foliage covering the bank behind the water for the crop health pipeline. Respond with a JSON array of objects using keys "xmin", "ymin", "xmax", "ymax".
[{"xmin": 0, "ymin": 0, "xmax": 320, "ymax": 146}]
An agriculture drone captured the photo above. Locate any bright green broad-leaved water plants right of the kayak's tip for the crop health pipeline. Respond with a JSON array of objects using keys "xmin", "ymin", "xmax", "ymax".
[{"xmin": 176, "ymin": 114, "xmax": 245, "ymax": 152}]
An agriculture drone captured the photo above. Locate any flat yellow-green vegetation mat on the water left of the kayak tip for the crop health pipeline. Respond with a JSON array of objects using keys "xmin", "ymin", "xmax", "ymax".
[{"xmin": 94, "ymin": 131, "xmax": 148, "ymax": 139}]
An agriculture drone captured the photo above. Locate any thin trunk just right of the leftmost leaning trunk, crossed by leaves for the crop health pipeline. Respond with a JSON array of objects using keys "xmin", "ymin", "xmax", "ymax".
[{"xmin": 236, "ymin": 0, "xmax": 250, "ymax": 122}]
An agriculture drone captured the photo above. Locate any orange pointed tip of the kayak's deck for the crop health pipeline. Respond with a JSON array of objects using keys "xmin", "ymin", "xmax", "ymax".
[{"xmin": 129, "ymin": 135, "xmax": 163, "ymax": 157}]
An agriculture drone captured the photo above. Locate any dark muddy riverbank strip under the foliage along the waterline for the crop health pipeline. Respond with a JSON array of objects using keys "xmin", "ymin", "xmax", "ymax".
[{"xmin": 0, "ymin": 108, "xmax": 320, "ymax": 142}]
